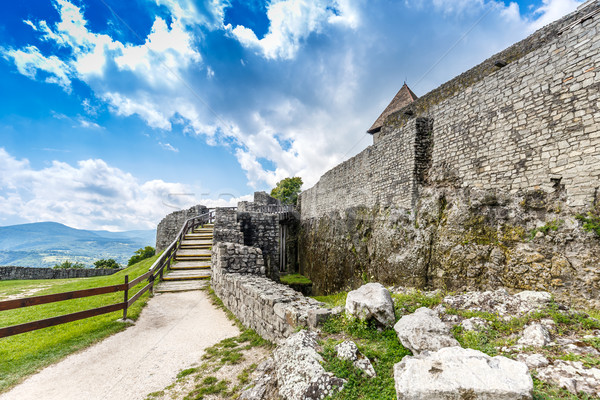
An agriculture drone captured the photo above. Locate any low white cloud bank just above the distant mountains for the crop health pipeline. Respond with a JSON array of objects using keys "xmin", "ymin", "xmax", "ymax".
[{"xmin": 0, "ymin": 148, "xmax": 250, "ymax": 230}]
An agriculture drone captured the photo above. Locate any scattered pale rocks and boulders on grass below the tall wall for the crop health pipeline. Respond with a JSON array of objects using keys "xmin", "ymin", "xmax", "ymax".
[{"xmin": 241, "ymin": 284, "xmax": 600, "ymax": 400}]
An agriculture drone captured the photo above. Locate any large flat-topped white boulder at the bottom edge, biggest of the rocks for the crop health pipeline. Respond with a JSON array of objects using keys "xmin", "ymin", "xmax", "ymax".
[{"xmin": 394, "ymin": 347, "xmax": 533, "ymax": 400}]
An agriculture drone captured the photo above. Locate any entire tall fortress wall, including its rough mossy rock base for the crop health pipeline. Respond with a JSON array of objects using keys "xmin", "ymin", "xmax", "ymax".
[{"xmin": 300, "ymin": 2, "xmax": 600, "ymax": 306}]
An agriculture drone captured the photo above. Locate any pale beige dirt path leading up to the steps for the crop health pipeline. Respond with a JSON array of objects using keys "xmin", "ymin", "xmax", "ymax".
[{"xmin": 0, "ymin": 291, "xmax": 240, "ymax": 400}]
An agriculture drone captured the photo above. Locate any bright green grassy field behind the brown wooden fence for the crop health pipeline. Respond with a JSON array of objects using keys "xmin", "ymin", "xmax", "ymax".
[{"xmin": 0, "ymin": 256, "xmax": 157, "ymax": 392}]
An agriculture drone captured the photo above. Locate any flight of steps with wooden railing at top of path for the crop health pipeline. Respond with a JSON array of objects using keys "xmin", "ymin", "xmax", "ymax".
[{"xmin": 156, "ymin": 224, "xmax": 213, "ymax": 292}]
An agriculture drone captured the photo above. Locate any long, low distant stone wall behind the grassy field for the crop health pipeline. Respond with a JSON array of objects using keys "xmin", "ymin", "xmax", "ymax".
[{"xmin": 0, "ymin": 266, "xmax": 120, "ymax": 281}]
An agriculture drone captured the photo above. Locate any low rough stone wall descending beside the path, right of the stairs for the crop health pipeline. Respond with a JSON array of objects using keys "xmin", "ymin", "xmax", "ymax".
[{"xmin": 211, "ymin": 243, "xmax": 331, "ymax": 342}]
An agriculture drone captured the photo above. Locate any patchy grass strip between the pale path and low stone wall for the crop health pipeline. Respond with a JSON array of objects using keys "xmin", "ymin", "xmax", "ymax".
[{"xmin": 146, "ymin": 288, "xmax": 274, "ymax": 400}]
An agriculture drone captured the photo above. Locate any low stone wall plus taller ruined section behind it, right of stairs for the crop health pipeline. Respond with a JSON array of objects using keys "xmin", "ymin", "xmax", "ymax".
[{"xmin": 211, "ymin": 198, "xmax": 331, "ymax": 342}]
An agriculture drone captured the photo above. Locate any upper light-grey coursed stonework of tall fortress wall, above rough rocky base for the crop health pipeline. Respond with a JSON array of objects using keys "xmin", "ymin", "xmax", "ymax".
[{"xmin": 301, "ymin": 3, "xmax": 600, "ymax": 219}]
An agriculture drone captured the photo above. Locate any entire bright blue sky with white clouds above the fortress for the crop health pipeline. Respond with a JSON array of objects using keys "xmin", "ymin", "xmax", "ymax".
[{"xmin": 0, "ymin": 0, "xmax": 581, "ymax": 230}]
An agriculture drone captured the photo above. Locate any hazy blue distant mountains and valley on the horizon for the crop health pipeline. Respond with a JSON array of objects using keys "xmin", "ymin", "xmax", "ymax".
[{"xmin": 0, "ymin": 222, "xmax": 156, "ymax": 267}]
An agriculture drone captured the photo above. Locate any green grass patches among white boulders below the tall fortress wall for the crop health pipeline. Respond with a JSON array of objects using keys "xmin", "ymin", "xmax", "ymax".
[{"xmin": 315, "ymin": 291, "xmax": 600, "ymax": 400}]
